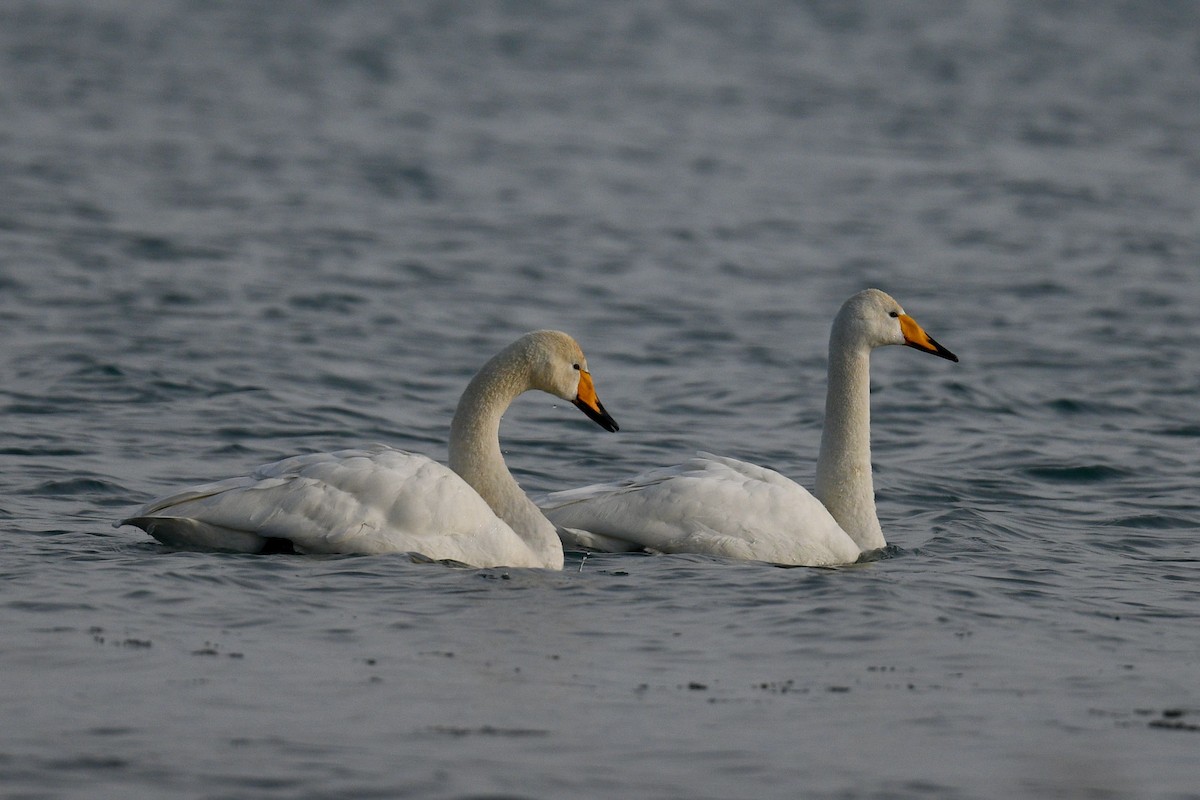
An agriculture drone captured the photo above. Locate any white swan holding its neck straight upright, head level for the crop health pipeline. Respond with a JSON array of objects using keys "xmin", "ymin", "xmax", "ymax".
[{"xmin": 539, "ymin": 289, "xmax": 959, "ymax": 566}]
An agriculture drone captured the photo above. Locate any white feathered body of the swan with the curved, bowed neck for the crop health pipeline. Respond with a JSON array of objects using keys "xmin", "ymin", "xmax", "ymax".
[{"xmin": 124, "ymin": 445, "xmax": 540, "ymax": 566}]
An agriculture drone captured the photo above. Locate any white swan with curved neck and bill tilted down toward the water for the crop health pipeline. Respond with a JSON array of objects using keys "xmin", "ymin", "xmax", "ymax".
[{"xmin": 115, "ymin": 331, "xmax": 617, "ymax": 570}]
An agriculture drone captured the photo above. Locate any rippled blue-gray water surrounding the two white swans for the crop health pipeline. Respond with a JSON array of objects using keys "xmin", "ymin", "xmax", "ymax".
[{"xmin": 0, "ymin": 0, "xmax": 1200, "ymax": 799}]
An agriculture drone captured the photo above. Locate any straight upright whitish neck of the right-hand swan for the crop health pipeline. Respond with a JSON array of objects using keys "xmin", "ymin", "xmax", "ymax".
[{"xmin": 816, "ymin": 324, "xmax": 887, "ymax": 551}]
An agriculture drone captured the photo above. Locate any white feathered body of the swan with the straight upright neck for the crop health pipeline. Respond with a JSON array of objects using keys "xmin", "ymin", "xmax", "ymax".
[{"xmin": 539, "ymin": 453, "xmax": 860, "ymax": 566}]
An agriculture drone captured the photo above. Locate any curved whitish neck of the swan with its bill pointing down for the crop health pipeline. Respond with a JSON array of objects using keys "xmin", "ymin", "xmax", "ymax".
[{"xmin": 450, "ymin": 347, "xmax": 563, "ymax": 567}]
